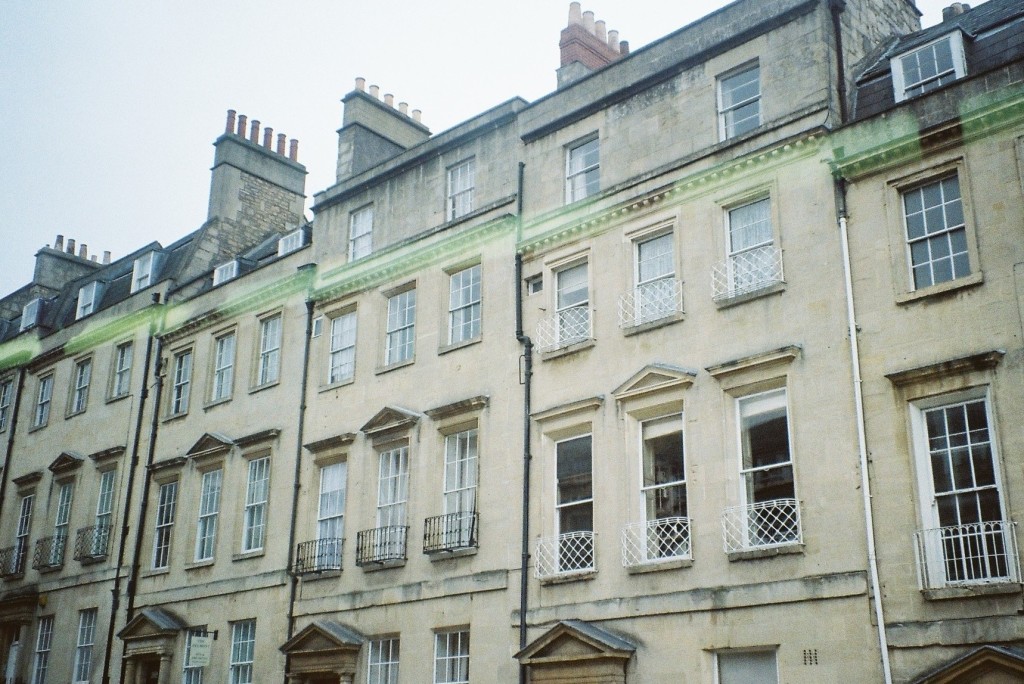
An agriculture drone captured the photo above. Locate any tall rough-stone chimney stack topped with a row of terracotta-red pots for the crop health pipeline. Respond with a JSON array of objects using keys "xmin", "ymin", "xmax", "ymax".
[{"xmin": 208, "ymin": 110, "xmax": 306, "ymax": 233}]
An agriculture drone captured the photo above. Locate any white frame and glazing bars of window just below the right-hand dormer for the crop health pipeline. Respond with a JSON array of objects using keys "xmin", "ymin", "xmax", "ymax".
[{"xmin": 899, "ymin": 169, "xmax": 973, "ymax": 291}]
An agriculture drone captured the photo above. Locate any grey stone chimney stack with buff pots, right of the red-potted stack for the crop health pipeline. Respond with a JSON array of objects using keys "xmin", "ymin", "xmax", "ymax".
[{"xmin": 337, "ymin": 78, "xmax": 430, "ymax": 182}]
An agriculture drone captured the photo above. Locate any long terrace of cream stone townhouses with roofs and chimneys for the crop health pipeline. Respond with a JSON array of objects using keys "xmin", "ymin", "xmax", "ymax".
[{"xmin": 0, "ymin": 0, "xmax": 1024, "ymax": 684}]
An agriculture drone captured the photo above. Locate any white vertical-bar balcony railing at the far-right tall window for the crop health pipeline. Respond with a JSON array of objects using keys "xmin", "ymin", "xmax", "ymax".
[{"xmin": 913, "ymin": 520, "xmax": 1021, "ymax": 590}]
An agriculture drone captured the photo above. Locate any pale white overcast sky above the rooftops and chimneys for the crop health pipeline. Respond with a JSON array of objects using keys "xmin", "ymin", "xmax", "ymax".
[{"xmin": 0, "ymin": 0, "xmax": 949, "ymax": 296}]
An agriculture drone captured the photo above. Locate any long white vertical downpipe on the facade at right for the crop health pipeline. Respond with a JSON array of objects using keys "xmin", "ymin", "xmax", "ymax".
[{"xmin": 836, "ymin": 179, "xmax": 893, "ymax": 684}]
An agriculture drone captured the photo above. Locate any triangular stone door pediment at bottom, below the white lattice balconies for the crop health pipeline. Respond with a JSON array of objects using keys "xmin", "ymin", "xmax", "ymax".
[{"xmin": 516, "ymin": 619, "xmax": 636, "ymax": 667}]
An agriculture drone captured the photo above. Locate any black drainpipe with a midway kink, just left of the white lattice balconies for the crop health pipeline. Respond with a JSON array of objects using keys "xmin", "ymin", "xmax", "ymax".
[{"xmin": 515, "ymin": 162, "xmax": 534, "ymax": 684}]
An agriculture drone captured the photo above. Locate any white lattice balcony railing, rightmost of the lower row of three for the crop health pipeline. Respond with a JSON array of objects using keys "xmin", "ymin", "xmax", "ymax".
[{"xmin": 722, "ymin": 499, "xmax": 803, "ymax": 553}]
